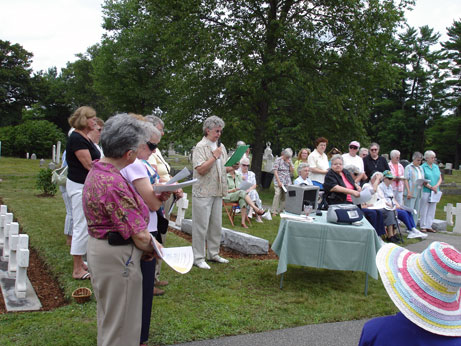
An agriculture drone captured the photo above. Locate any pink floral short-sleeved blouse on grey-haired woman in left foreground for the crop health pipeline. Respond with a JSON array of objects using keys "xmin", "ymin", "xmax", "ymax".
[{"xmin": 82, "ymin": 161, "xmax": 149, "ymax": 239}]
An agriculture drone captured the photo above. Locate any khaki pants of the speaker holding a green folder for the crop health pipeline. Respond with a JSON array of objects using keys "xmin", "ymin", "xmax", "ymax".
[{"xmin": 192, "ymin": 197, "xmax": 222, "ymax": 264}]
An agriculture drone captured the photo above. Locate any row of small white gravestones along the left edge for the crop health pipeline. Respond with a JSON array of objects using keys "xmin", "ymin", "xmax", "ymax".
[{"xmin": 0, "ymin": 205, "xmax": 29, "ymax": 298}]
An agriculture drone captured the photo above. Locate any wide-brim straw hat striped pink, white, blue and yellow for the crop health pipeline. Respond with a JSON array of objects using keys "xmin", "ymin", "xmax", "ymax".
[{"xmin": 376, "ymin": 242, "xmax": 461, "ymax": 336}]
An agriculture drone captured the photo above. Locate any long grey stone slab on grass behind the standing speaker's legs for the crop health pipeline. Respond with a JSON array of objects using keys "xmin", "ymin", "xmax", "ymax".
[{"xmin": 181, "ymin": 219, "xmax": 269, "ymax": 255}]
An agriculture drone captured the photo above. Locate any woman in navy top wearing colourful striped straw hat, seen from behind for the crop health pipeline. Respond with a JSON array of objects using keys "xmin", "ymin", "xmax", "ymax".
[{"xmin": 359, "ymin": 242, "xmax": 461, "ymax": 346}]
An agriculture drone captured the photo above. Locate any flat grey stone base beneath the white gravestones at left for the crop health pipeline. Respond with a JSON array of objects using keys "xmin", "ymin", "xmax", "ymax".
[{"xmin": 0, "ymin": 255, "xmax": 42, "ymax": 312}]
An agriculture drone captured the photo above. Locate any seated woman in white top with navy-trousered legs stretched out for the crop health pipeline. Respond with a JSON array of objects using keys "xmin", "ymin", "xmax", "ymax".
[{"xmin": 378, "ymin": 171, "xmax": 427, "ymax": 241}]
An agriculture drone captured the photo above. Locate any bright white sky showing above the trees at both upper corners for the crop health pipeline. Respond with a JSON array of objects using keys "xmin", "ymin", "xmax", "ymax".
[{"xmin": 0, "ymin": 0, "xmax": 461, "ymax": 72}]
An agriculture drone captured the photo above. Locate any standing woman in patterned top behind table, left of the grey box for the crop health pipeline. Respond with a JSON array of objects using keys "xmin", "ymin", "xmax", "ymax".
[{"xmin": 272, "ymin": 148, "xmax": 294, "ymax": 216}]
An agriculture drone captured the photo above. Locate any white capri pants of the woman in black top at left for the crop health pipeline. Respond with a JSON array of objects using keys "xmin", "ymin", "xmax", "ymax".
[{"xmin": 66, "ymin": 179, "xmax": 88, "ymax": 256}]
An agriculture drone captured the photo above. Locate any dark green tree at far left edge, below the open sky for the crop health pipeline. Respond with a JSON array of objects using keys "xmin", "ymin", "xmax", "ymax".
[{"xmin": 0, "ymin": 40, "xmax": 34, "ymax": 126}]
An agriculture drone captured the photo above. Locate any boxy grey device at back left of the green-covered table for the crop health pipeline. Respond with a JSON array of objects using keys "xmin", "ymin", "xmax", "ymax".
[{"xmin": 285, "ymin": 185, "xmax": 319, "ymax": 215}]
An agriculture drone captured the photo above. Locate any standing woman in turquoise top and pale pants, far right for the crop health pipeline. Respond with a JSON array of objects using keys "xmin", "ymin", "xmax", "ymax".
[{"xmin": 419, "ymin": 150, "xmax": 442, "ymax": 233}]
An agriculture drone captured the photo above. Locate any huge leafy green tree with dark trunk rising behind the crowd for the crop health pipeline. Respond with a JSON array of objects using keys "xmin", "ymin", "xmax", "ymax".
[{"xmin": 100, "ymin": 0, "xmax": 411, "ymax": 180}]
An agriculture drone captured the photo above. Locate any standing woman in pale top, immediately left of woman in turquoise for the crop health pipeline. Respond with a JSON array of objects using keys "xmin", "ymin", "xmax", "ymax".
[{"xmin": 403, "ymin": 151, "xmax": 424, "ymax": 223}]
